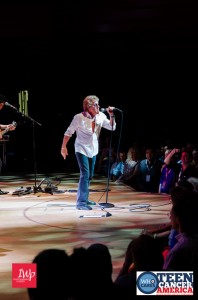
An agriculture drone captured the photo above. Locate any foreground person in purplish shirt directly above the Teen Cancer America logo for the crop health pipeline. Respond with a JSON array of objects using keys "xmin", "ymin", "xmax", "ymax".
[{"xmin": 163, "ymin": 187, "xmax": 198, "ymax": 274}]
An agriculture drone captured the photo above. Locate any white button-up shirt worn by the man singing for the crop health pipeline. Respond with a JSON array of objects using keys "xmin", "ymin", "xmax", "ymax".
[{"xmin": 64, "ymin": 112, "xmax": 116, "ymax": 158}]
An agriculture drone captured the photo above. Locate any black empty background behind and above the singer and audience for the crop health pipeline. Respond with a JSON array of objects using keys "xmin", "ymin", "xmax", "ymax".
[{"xmin": 0, "ymin": 0, "xmax": 198, "ymax": 171}]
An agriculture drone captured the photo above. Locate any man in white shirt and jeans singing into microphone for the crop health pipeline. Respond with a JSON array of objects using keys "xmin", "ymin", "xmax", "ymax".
[{"xmin": 61, "ymin": 95, "xmax": 116, "ymax": 210}]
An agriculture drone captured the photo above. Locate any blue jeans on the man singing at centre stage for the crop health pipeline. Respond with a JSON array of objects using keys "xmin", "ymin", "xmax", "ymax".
[{"xmin": 76, "ymin": 152, "xmax": 96, "ymax": 205}]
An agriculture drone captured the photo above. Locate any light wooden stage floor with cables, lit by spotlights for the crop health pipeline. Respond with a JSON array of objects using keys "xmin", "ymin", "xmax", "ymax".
[{"xmin": 0, "ymin": 172, "xmax": 171, "ymax": 300}]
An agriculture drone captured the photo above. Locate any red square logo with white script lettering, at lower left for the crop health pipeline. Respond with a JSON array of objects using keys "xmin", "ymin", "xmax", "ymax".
[{"xmin": 12, "ymin": 263, "xmax": 37, "ymax": 288}]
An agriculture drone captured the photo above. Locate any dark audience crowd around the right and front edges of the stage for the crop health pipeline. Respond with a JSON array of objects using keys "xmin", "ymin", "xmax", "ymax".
[{"xmin": 28, "ymin": 139, "xmax": 198, "ymax": 300}]
